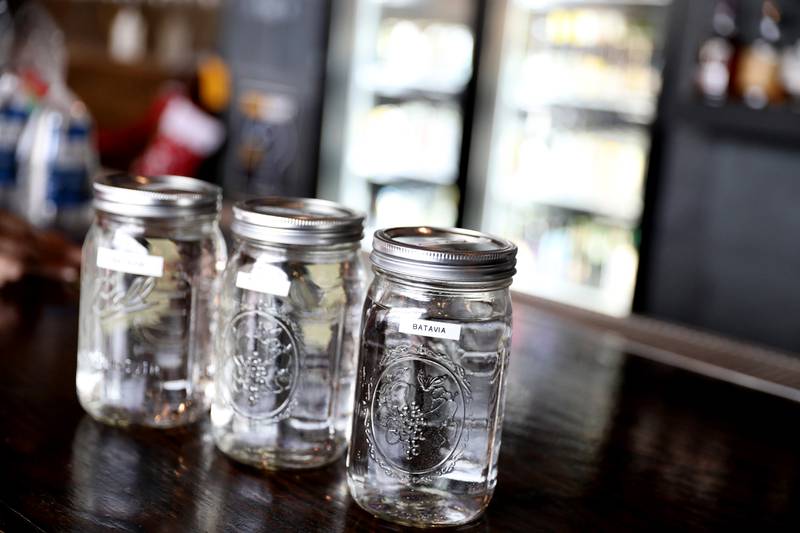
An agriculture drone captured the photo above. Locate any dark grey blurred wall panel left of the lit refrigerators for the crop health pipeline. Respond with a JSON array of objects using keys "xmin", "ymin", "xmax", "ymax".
[{"xmin": 221, "ymin": 0, "xmax": 331, "ymax": 198}]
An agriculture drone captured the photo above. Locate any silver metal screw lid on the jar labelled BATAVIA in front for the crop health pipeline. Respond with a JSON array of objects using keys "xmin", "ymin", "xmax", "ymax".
[{"xmin": 370, "ymin": 227, "xmax": 517, "ymax": 283}]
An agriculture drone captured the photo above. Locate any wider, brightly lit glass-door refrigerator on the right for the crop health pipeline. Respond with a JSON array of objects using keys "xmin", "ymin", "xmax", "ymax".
[{"xmin": 465, "ymin": 0, "xmax": 669, "ymax": 315}]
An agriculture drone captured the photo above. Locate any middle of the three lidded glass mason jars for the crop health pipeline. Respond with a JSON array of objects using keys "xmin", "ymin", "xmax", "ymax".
[{"xmin": 211, "ymin": 197, "xmax": 365, "ymax": 469}]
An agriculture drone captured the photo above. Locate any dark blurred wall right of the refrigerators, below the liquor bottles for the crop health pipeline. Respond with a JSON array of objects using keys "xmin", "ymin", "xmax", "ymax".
[{"xmin": 634, "ymin": 0, "xmax": 800, "ymax": 351}]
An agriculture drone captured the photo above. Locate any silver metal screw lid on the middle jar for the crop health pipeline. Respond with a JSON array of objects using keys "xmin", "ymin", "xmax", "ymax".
[{"xmin": 231, "ymin": 196, "xmax": 364, "ymax": 246}]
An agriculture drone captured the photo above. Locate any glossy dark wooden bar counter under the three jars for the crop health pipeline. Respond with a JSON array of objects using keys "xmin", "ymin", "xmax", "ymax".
[{"xmin": 0, "ymin": 286, "xmax": 800, "ymax": 532}]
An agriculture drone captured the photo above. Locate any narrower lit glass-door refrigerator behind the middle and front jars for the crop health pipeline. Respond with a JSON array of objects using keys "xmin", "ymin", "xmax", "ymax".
[{"xmin": 318, "ymin": 0, "xmax": 485, "ymax": 239}]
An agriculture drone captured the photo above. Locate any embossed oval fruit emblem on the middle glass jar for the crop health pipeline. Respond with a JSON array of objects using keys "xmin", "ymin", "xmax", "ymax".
[{"xmin": 224, "ymin": 311, "xmax": 300, "ymax": 419}]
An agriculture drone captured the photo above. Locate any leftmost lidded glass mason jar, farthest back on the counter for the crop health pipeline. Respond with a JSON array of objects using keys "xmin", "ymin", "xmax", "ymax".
[{"xmin": 76, "ymin": 174, "xmax": 227, "ymax": 427}]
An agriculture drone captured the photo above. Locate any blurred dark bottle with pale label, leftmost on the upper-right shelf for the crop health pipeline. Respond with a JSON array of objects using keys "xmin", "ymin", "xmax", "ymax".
[{"xmin": 696, "ymin": 0, "xmax": 738, "ymax": 105}]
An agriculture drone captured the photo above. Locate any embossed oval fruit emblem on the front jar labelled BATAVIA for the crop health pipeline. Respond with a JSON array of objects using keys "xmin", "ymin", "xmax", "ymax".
[{"xmin": 371, "ymin": 357, "xmax": 464, "ymax": 474}]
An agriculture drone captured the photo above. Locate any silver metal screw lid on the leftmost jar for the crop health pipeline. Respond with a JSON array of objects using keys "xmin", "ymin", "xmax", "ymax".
[{"xmin": 94, "ymin": 174, "xmax": 222, "ymax": 218}]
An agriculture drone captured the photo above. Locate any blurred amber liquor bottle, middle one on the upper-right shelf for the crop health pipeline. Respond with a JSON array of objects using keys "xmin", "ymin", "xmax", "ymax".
[{"xmin": 736, "ymin": 0, "xmax": 784, "ymax": 109}]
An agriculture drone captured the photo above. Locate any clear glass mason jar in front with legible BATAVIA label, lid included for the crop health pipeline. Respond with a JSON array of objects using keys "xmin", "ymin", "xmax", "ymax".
[{"xmin": 347, "ymin": 224, "xmax": 516, "ymax": 526}]
